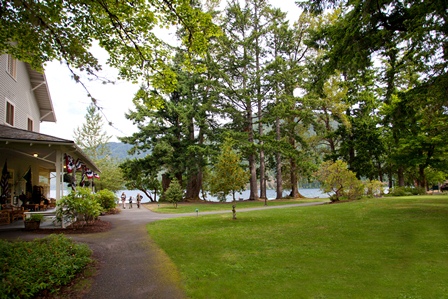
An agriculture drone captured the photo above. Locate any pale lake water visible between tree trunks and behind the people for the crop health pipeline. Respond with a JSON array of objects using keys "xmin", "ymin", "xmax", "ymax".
[{"xmin": 116, "ymin": 189, "xmax": 329, "ymax": 203}]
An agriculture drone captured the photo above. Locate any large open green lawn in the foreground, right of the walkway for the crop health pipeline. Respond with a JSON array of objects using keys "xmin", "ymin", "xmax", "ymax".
[{"xmin": 148, "ymin": 196, "xmax": 448, "ymax": 299}]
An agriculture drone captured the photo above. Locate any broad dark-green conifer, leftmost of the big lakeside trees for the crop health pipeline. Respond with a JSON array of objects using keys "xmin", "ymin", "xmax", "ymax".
[{"xmin": 121, "ymin": 49, "xmax": 217, "ymax": 200}]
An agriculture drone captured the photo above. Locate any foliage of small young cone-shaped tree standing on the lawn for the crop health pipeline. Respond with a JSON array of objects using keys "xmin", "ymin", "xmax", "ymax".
[{"xmin": 209, "ymin": 138, "xmax": 249, "ymax": 201}]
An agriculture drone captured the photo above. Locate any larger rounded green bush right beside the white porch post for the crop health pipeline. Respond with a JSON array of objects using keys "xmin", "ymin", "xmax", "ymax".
[{"xmin": 56, "ymin": 187, "xmax": 102, "ymax": 223}]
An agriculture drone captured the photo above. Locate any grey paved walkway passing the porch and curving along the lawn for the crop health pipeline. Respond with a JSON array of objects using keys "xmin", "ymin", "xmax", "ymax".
[{"xmin": 0, "ymin": 202, "xmax": 323, "ymax": 299}]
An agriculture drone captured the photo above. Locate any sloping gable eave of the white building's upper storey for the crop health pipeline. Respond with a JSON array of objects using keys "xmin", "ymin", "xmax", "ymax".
[{"xmin": 25, "ymin": 63, "xmax": 56, "ymax": 122}]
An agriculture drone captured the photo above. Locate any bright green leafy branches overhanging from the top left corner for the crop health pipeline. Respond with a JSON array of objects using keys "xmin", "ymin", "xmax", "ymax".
[{"xmin": 0, "ymin": 0, "xmax": 219, "ymax": 90}]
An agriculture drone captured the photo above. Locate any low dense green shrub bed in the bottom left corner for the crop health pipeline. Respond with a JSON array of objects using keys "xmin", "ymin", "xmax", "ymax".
[{"xmin": 0, "ymin": 235, "xmax": 92, "ymax": 298}]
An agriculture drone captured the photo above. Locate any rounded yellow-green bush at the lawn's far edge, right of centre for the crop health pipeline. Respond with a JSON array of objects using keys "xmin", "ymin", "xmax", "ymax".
[{"xmin": 315, "ymin": 160, "xmax": 364, "ymax": 201}]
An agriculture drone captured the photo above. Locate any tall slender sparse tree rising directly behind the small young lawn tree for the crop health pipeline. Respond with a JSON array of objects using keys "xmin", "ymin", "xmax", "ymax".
[{"xmin": 216, "ymin": 0, "xmax": 258, "ymax": 200}]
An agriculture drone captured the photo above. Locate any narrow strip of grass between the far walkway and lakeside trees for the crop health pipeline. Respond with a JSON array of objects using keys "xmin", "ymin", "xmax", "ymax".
[{"xmin": 144, "ymin": 198, "xmax": 330, "ymax": 214}]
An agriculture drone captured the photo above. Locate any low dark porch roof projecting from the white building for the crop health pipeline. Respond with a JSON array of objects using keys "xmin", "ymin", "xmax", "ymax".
[{"xmin": 0, "ymin": 125, "xmax": 100, "ymax": 172}]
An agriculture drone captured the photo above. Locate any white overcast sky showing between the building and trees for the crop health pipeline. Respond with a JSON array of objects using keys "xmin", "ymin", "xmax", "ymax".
[{"xmin": 40, "ymin": 0, "xmax": 300, "ymax": 142}]
